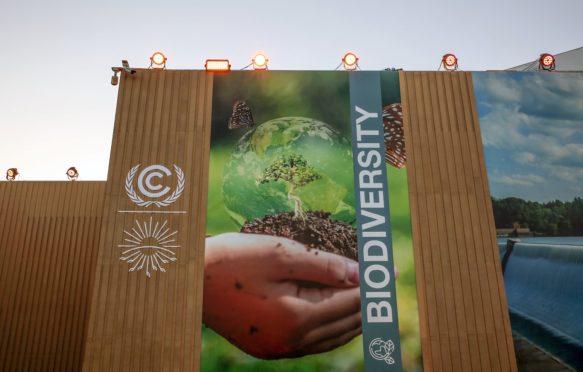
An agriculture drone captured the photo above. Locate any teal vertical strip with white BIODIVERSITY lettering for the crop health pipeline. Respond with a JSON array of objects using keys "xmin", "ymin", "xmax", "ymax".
[{"xmin": 349, "ymin": 71, "xmax": 402, "ymax": 372}]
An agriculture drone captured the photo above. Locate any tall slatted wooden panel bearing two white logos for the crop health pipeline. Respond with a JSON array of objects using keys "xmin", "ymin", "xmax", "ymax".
[{"xmin": 84, "ymin": 70, "xmax": 212, "ymax": 371}]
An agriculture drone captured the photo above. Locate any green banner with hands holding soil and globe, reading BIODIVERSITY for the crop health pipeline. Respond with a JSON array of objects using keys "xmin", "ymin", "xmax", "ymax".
[{"xmin": 201, "ymin": 71, "xmax": 421, "ymax": 371}]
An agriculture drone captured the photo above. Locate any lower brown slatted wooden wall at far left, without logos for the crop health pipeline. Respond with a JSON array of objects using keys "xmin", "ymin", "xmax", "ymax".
[{"xmin": 0, "ymin": 182, "xmax": 105, "ymax": 371}]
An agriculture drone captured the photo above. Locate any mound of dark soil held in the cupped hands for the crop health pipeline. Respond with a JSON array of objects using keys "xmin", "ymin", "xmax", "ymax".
[{"xmin": 241, "ymin": 212, "xmax": 358, "ymax": 260}]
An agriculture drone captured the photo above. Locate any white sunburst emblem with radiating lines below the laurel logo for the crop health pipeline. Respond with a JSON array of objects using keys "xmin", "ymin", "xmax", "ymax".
[{"xmin": 118, "ymin": 217, "xmax": 180, "ymax": 278}]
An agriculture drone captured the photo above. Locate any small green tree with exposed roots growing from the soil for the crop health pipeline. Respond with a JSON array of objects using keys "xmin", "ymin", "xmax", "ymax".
[{"xmin": 257, "ymin": 154, "xmax": 322, "ymax": 221}]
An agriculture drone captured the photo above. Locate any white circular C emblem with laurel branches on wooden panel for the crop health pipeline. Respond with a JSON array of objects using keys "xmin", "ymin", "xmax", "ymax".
[{"xmin": 125, "ymin": 164, "xmax": 185, "ymax": 208}]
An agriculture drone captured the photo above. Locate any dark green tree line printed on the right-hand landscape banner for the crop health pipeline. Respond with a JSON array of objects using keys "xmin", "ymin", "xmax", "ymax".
[{"xmin": 492, "ymin": 197, "xmax": 583, "ymax": 236}]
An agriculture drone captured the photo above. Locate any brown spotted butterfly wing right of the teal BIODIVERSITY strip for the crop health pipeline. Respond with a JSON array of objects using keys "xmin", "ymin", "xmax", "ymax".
[{"xmin": 383, "ymin": 103, "xmax": 407, "ymax": 168}]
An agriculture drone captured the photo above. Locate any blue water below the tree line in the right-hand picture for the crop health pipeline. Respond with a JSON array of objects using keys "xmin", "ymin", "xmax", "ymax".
[{"xmin": 498, "ymin": 236, "xmax": 583, "ymax": 371}]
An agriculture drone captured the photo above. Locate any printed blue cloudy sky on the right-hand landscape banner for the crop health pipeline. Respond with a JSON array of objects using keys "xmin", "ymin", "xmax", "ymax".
[{"xmin": 473, "ymin": 72, "xmax": 583, "ymax": 202}]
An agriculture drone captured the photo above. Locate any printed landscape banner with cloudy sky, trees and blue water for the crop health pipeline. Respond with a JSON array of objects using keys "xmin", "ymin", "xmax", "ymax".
[{"xmin": 472, "ymin": 72, "xmax": 583, "ymax": 370}]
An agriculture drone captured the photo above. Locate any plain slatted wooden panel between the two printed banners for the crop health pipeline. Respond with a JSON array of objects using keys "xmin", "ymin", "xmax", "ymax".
[{"xmin": 400, "ymin": 72, "xmax": 516, "ymax": 371}]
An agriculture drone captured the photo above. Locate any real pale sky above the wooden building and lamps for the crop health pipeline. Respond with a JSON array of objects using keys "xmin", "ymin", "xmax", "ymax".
[{"xmin": 0, "ymin": 0, "xmax": 583, "ymax": 180}]
